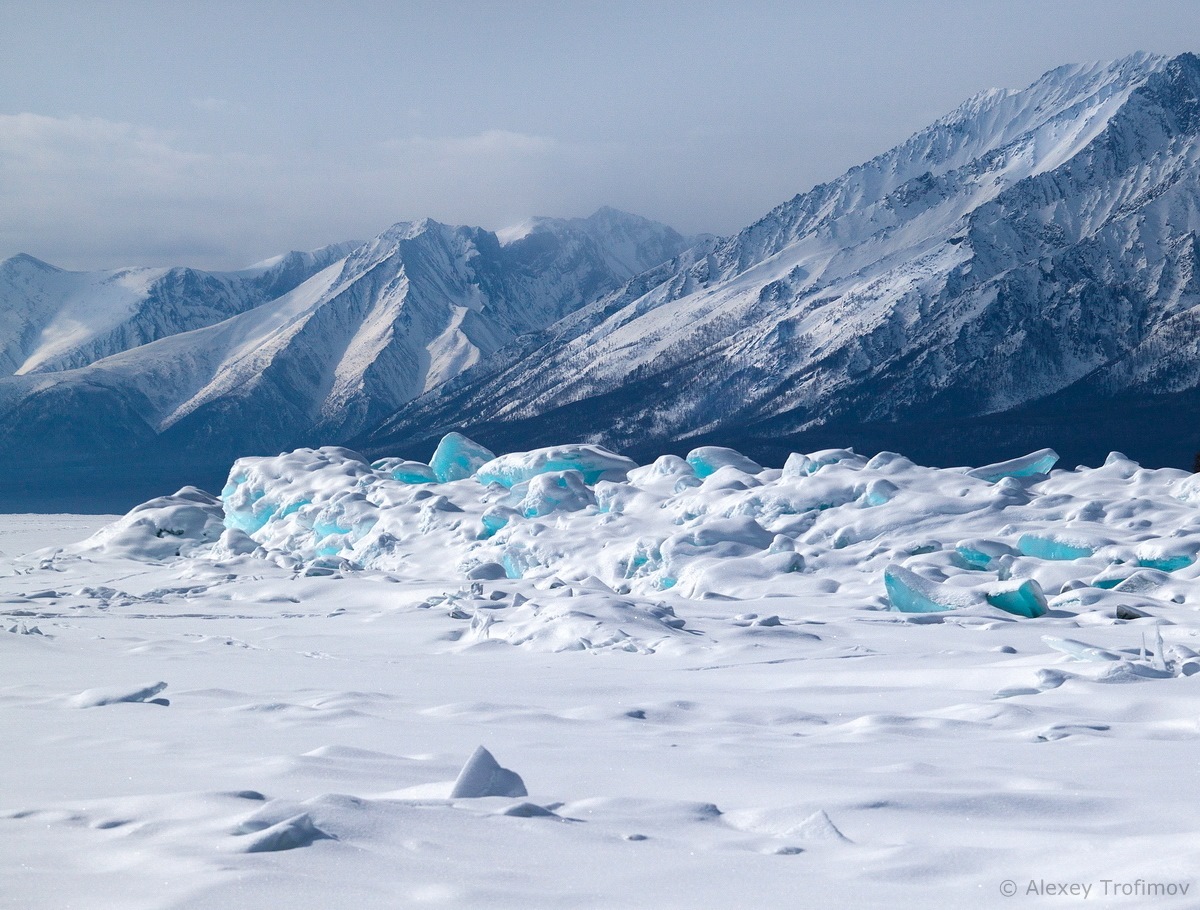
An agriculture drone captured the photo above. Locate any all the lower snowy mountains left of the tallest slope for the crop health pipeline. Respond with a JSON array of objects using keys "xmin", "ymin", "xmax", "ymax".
[{"xmin": 0, "ymin": 209, "xmax": 689, "ymax": 513}]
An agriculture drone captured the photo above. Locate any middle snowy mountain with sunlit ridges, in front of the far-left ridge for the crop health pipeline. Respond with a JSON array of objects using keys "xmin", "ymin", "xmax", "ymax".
[{"xmin": 0, "ymin": 210, "xmax": 688, "ymax": 506}]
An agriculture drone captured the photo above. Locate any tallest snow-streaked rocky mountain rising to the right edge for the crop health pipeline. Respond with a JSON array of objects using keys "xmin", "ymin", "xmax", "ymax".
[{"xmin": 365, "ymin": 54, "xmax": 1200, "ymax": 463}]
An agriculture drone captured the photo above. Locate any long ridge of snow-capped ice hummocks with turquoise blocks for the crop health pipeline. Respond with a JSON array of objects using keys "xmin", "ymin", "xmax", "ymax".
[{"xmin": 68, "ymin": 444, "xmax": 1200, "ymax": 633}]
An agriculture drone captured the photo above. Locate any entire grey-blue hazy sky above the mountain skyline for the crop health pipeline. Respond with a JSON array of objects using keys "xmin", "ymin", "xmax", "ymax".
[{"xmin": 0, "ymin": 0, "xmax": 1200, "ymax": 269}]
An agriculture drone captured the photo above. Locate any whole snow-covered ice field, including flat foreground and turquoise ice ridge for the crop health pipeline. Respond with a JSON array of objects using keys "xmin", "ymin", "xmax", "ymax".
[{"xmin": 0, "ymin": 435, "xmax": 1200, "ymax": 908}]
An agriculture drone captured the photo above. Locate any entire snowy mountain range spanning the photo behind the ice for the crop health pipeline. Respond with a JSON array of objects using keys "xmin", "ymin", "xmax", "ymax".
[{"xmin": 0, "ymin": 54, "xmax": 1200, "ymax": 507}]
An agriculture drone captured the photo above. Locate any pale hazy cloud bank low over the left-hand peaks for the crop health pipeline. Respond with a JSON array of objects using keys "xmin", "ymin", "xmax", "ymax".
[{"xmin": 0, "ymin": 113, "xmax": 638, "ymax": 268}]
